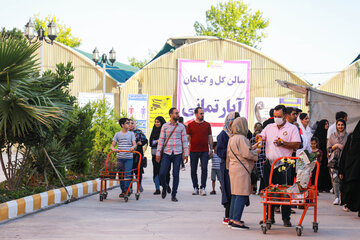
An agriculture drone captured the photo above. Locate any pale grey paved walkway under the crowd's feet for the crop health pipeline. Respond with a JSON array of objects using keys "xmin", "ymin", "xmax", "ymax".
[{"xmin": 0, "ymin": 164, "xmax": 360, "ymax": 240}]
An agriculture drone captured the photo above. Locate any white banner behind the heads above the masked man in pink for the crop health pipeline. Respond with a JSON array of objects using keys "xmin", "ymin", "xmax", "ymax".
[{"xmin": 250, "ymin": 97, "xmax": 301, "ymax": 124}]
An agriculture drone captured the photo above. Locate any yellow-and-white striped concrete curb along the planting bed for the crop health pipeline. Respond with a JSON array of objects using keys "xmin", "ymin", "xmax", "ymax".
[{"xmin": 0, "ymin": 178, "xmax": 119, "ymax": 223}]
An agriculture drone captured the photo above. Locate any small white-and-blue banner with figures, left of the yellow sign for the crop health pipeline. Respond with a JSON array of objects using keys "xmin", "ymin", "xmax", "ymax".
[{"xmin": 127, "ymin": 94, "xmax": 148, "ymax": 133}]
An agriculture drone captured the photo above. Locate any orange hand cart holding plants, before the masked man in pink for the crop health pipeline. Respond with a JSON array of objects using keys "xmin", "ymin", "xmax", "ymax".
[{"xmin": 261, "ymin": 157, "xmax": 320, "ymax": 236}]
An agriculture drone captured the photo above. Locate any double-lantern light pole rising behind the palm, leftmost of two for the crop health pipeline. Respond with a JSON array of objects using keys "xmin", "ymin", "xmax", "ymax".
[{"xmin": 25, "ymin": 18, "xmax": 57, "ymax": 76}]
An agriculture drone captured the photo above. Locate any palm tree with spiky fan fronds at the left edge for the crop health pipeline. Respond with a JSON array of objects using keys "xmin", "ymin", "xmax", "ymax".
[{"xmin": 0, "ymin": 37, "xmax": 71, "ymax": 189}]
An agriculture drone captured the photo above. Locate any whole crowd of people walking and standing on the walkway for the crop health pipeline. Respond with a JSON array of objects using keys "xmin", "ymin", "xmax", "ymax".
[{"xmin": 111, "ymin": 105, "xmax": 360, "ymax": 229}]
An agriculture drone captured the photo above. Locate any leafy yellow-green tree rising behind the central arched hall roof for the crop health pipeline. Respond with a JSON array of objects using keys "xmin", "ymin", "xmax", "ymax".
[{"xmin": 194, "ymin": 0, "xmax": 269, "ymax": 48}]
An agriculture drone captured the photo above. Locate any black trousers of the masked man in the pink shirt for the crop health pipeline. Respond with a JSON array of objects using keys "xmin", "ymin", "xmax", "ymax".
[{"xmin": 264, "ymin": 161, "xmax": 294, "ymax": 221}]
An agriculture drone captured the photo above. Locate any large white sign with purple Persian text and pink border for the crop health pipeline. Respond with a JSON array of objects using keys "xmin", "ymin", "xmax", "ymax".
[{"xmin": 177, "ymin": 59, "xmax": 250, "ymax": 136}]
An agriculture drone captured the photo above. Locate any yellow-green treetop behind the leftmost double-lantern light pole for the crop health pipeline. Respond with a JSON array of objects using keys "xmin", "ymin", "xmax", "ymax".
[{"xmin": 34, "ymin": 14, "xmax": 81, "ymax": 48}]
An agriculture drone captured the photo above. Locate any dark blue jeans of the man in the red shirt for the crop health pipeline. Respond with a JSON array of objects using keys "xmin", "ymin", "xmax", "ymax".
[{"xmin": 190, "ymin": 152, "xmax": 209, "ymax": 189}]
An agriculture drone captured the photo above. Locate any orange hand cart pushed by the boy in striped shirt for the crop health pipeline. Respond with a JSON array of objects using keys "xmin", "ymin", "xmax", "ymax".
[{"xmin": 99, "ymin": 150, "xmax": 141, "ymax": 202}]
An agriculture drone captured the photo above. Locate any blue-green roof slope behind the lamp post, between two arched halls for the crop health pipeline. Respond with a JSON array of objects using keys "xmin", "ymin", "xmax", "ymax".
[{"xmin": 73, "ymin": 48, "xmax": 139, "ymax": 83}]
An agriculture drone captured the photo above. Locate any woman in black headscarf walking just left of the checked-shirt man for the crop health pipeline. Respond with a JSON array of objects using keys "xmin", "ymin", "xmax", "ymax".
[{"xmin": 150, "ymin": 116, "xmax": 170, "ymax": 195}]
